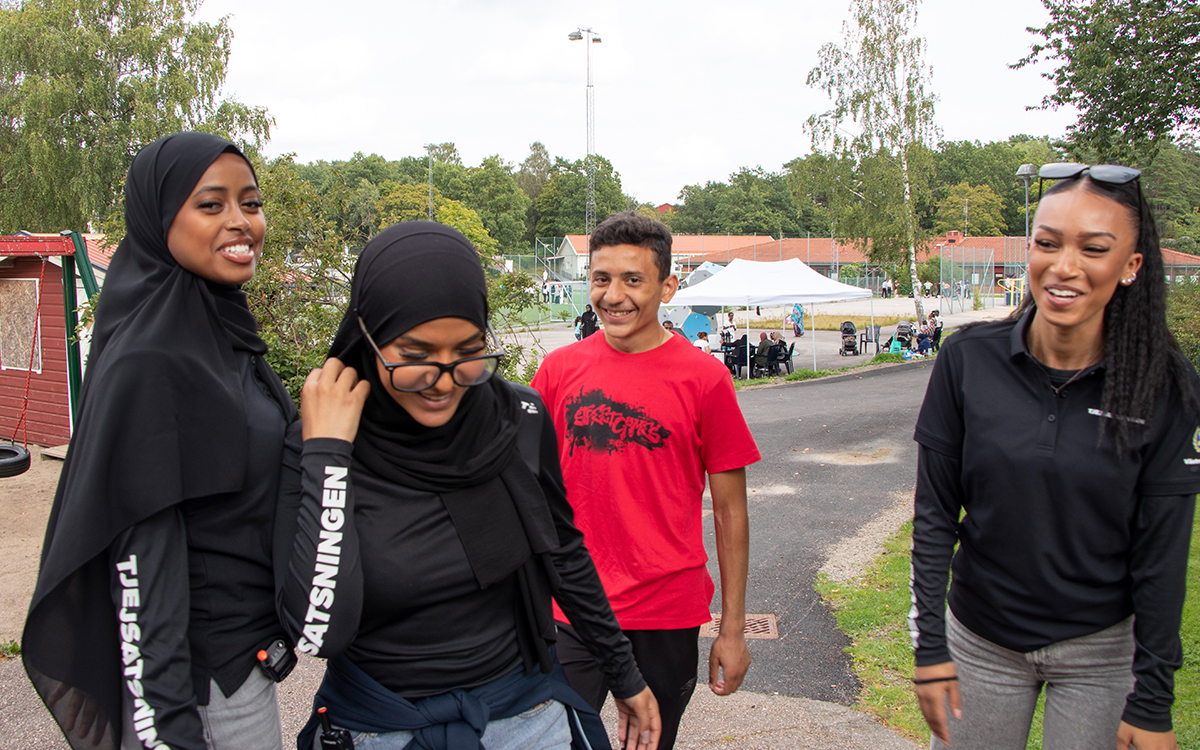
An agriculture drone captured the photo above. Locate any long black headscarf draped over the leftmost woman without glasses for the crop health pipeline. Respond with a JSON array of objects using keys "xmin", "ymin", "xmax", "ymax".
[{"xmin": 22, "ymin": 133, "xmax": 295, "ymax": 748}]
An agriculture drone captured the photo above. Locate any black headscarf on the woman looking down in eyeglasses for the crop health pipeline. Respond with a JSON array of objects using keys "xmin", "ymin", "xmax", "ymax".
[{"xmin": 329, "ymin": 221, "xmax": 558, "ymax": 587}]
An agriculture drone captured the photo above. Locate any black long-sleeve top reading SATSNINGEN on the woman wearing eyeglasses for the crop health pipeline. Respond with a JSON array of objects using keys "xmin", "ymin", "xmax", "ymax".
[{"xmin": 276, "ymin": 400, "xmax": 646, "ymax": 700}]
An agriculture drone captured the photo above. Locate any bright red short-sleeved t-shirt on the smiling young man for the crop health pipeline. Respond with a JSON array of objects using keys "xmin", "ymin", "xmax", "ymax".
[{"xmin": 533, "ymin": 334, "xmax": 760, "ymax": 630}]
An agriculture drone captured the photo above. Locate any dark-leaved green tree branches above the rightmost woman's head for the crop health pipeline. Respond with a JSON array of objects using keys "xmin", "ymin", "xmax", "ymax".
[{"xmin": 1013, "ymin": 0, "xmax": 1200, "ymax": 163}]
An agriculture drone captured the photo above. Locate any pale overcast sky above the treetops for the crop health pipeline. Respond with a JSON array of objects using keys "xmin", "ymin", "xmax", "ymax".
[{"xmin": 200, "ymin": 0, "xmax": 1075, "ymax": 204}]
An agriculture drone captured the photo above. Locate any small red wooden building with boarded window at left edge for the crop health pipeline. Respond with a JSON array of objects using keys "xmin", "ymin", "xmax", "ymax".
[{"xmin": 0, "ymin": 235, "xmax": 95, "ymax": 445}]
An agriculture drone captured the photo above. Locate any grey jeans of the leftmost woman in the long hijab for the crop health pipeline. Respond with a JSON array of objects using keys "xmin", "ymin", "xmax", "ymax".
[{"xmin": 121, "ymin": 667, "xmax": 283, "ymax": 750}]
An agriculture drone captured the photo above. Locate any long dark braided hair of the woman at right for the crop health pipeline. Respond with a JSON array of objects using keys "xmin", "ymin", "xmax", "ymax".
[{"xmin": 1014, "ymin": 174, "xmax": 1200, "ymax": 452}]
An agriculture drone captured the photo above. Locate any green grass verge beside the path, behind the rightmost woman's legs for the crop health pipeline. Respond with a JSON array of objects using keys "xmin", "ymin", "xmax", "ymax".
[{"xmin": 816, "ymin": 506, "xmax": 1200, "ymax": 750}]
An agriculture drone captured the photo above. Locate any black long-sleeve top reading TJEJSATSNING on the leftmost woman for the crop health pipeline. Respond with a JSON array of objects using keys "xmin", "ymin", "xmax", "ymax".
[{"xmin": 108, "ymin": 350, "xmax": 294, "ymax": 750}]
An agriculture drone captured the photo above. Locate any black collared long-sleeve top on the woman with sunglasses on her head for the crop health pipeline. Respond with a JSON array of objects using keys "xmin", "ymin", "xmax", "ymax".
[{"xmin": 910, "ymin": 317, "xmax": 1200, "ymax": 731}]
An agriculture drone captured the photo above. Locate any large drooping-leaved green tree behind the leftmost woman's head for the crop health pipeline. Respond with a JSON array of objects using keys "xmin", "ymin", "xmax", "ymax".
[{"xmin": 0, "ymin": 0, "xmax": 272, "ymax": 232}]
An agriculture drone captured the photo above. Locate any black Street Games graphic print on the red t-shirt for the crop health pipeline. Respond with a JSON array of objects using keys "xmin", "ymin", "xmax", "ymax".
[{"xmin": 566, "ymin": 389, "xmax": 671, "ymax": 456}]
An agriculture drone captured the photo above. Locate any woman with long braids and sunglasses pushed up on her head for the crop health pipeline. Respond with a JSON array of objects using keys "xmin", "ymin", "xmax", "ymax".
[{"xmin": 910, "ymin": 164, "xmax": 1200, "ymax": 750}]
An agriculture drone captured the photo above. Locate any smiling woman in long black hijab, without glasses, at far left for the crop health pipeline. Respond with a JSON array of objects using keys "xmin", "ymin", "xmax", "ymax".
[{"xmin": 22, "ymin": 133, "xmax": 296, "ymax": 750}]
